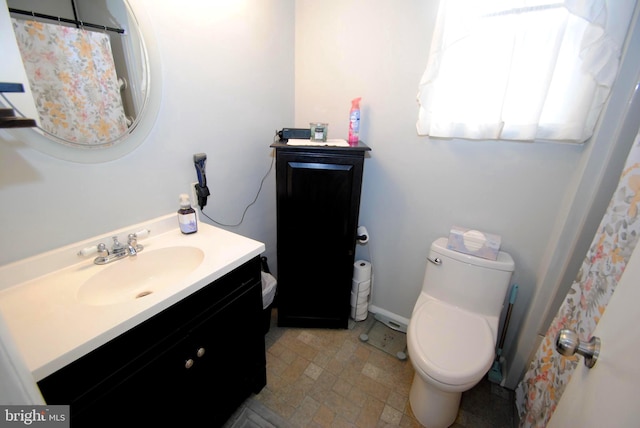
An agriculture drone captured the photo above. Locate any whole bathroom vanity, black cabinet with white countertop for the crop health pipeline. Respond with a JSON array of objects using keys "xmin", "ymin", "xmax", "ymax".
[{"xmin": 0, "ymin": 215, "xmax": 266, "ymax": 427}]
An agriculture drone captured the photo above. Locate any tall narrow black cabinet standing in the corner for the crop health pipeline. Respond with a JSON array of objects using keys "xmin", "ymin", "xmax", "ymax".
[{"xmin": 271, "ymin": 143, "xmax": 370, "ymax": 328}]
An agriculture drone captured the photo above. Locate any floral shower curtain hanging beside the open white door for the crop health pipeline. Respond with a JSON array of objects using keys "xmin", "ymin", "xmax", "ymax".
[{"xmin": 516, "ymin": 133, "xmax": 640, "ymax": 427}]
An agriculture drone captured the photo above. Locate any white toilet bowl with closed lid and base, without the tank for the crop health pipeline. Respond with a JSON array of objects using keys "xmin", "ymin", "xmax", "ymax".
[{"xmin": 407, "ymin": 294, "xmax": 497, "ymax": 428}]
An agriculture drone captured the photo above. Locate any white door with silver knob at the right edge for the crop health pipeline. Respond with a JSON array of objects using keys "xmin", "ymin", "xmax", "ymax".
[{"xmin": 548, "ymin": 247, "xmax": 640, "ymax": 428}]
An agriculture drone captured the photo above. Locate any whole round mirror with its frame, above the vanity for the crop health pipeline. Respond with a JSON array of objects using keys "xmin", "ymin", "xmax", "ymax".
[{"xmin": 2, "ymin": 0, "xmax": 161, "ymax": 163}]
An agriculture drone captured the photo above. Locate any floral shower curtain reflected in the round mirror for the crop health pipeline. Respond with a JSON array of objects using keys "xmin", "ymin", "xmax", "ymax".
[{"xmin": 12, "ymin": 19, "xmax": 127, "ymax": 147}]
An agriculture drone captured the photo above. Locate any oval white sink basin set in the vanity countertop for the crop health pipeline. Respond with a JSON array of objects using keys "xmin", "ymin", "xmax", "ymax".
[{"xmin": 77, "ymin": 246, "xmax": 204, "ymax": 306}]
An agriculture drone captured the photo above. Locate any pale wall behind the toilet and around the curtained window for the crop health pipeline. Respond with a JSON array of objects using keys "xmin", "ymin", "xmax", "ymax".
[{"xmin": 295, "ymin": 0, "xmax": 633, "ymax": 388}]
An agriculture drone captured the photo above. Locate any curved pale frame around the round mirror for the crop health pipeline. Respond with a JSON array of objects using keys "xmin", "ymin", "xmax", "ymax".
[{"xmin": 10, "ymin": 0, "xmax": 162, "ymax": 163}]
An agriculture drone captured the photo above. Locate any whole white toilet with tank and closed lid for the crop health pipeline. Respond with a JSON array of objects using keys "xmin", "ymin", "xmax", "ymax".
[{"xmin": 407, "ymin": 238, "xmax": 514, "ymax": 428}]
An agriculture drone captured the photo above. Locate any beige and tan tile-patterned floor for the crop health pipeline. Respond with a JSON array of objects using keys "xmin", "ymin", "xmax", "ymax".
[{"xmin": 226, "ymin": 310, "xmax": 515, "ymax": 428}]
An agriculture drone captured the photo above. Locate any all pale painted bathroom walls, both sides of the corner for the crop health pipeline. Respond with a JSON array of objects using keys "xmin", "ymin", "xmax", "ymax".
[{"xmin": 0, "ymin": 0, "xmax": 640, "ymax": 394}]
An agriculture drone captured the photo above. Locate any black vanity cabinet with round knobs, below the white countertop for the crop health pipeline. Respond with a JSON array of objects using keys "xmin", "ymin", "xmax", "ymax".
[{"xmin": 38, "ymin": 257, "xmax": 266, "ymax": 428}]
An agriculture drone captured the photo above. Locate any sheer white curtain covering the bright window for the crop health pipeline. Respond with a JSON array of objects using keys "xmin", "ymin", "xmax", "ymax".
[{"xmin": 417, "ymin": 0, "xmax": 636, "ymax": 143}]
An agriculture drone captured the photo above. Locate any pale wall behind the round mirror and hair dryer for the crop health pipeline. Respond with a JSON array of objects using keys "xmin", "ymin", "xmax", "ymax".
[{"xmin": 0, "ymin": 0, "xmax": 294, "ymax": 264}]
